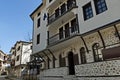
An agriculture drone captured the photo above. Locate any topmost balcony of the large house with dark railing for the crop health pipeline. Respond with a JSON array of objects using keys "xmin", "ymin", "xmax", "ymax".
[{"xmin": 48, "ymin": 0, "xmax": 77, "ymax": 25}]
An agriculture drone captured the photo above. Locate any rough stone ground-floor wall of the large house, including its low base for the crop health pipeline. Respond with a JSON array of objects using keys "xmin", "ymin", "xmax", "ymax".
[{"xmin": 37, "ymin": 19, "xmax": 120, "ymax": 80}]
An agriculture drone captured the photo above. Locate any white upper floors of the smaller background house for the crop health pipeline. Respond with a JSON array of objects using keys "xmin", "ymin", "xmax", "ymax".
[{"xmin": 10, "ymin": 41, "xmax": 32, "ymax": 66}]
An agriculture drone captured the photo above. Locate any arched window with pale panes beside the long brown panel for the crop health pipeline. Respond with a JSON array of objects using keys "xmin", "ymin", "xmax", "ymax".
[{"xmin": 92, "ymin": 43, "xmax": 102, "ymax": 62}]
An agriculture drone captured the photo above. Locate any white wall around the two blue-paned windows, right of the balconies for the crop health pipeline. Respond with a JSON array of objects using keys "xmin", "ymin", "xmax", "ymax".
[{"xmin": 76, "ymin": 0, "xmax": 120, "ymax": 34}]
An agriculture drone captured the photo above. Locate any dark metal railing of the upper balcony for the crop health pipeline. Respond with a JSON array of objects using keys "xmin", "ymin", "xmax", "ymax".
[{"xmin": 48, "ymin": 0, "xmax": 76, "ymax": 24}]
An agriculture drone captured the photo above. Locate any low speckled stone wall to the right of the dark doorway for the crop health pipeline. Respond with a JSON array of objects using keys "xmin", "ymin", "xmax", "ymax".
[{"xmin": 75, "ymin": 60, "xmax": 120, "ymax": 77}]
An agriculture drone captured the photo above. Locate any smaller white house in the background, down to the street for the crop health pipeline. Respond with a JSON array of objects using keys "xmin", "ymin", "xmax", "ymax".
[{"xmin": 10, "ymin": 41, "xmax": 32, "ymax": 77}]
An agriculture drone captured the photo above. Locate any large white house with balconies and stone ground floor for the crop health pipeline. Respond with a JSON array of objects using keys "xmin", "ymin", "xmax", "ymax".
[{"xmin": 30, "ymin": 0, "xmax": 120, "ymax": 80}]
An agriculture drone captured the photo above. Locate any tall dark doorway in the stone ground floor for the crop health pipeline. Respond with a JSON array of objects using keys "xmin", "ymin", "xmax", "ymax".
[{"xmin": 68, "ymin": 52, "xmax": 75, "ymax": 75}]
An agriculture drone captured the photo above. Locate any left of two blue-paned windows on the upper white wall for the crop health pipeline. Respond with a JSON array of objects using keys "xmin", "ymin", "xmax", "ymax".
[{"xmin": 83, "ymin": 2, "xmax": 93, "ymax": 20}]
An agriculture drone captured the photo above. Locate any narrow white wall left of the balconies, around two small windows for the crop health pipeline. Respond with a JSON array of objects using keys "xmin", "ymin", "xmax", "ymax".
[{"xmin": 33, "ymin": 8, "xmax": 47, "ymax": 54}]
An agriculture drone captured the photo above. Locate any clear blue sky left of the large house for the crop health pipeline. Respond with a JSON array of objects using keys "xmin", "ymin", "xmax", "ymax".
[{"xmin": 0, "ymin": 0, "xmax": 41, "ymax": 54}]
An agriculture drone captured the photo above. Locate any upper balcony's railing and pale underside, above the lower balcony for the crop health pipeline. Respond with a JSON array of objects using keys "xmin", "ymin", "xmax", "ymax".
[{"xmin": 48, "ymin": 1, "xmax": 78, "ymax": 27}]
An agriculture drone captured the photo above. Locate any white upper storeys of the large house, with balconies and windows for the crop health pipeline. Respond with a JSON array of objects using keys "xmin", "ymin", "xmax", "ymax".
[{"xmin": 30, "ymin": 0, "xmax": 120, "ymax": 53}]
